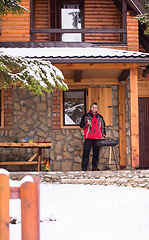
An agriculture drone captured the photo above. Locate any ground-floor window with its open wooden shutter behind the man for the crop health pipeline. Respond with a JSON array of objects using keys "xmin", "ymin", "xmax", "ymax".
[{"xmin": 60, "ymin": 87, "xmax": 112, "ymax": 128}]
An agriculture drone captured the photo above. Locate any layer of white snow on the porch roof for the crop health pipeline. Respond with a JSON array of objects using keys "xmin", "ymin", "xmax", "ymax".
[{"xmin": 0, "ymin": 47, "xmax": 149, "ymax": 59}]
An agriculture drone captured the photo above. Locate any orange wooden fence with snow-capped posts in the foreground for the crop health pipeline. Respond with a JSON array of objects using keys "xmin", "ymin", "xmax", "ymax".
[{"xmin": 0, "ymin": 170, "xmax": 40, "ymax": 240}]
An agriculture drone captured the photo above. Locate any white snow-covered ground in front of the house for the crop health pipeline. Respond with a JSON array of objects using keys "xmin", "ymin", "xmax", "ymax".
[{"xmin": 10, "ymin": 183, "xmax": 149, "ymax": 240}]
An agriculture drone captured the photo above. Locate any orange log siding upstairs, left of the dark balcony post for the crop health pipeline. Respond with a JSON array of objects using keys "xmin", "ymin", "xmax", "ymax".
[{"xmin": 0, "ymin": 0, "xmax": 30, "ymax": 42}]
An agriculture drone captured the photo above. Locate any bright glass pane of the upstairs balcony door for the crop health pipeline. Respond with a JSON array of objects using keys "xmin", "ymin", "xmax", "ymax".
[{"xmin": 61, "ymin": 4, "xmax": 81, "ymax": 42}]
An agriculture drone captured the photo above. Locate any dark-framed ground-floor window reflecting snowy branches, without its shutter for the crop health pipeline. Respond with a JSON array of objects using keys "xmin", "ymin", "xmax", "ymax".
[{"xmin": 63, "ymin": 89, "xmax": 86, "ymax": 126}]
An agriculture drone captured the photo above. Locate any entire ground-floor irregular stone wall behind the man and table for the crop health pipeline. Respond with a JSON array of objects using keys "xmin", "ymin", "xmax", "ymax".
[{"xmin": 0, "ymin": 86, "xmax": 130, "ymax": 171}]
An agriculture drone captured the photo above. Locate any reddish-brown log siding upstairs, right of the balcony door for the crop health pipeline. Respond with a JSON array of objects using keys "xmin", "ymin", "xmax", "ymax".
[{"xmin": 85, "ymin": 0, "xmax": 121, "ymax": 42}]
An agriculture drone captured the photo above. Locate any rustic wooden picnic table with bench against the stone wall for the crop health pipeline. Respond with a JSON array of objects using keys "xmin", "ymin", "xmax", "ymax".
[{"xmin": 0, "ymin": 142, "xmax": 51, "ymax": 171}]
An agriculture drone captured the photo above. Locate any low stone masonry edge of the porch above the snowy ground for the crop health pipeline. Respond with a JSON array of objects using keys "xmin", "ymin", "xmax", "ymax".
[{"xmin": 10, "ymin": 170, "xmax": 149, "ymax": 189}]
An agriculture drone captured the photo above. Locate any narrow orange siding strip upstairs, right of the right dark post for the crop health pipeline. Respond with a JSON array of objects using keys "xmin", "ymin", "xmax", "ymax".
[{"xmin": 127, "ymin": 13, "xmax": 139, "ymax": 51}]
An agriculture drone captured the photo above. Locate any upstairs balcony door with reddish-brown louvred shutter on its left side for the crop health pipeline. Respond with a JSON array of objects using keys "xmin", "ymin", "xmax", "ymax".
[{"xmin": 32, "ymin": 0, "xmax": 84, "ymax": 42}]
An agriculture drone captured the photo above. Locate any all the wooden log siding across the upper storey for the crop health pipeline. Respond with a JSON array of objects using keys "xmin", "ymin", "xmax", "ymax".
[{"xmin": 0, "ymin": 0, "xmax": 139, "ymax": 51}]
